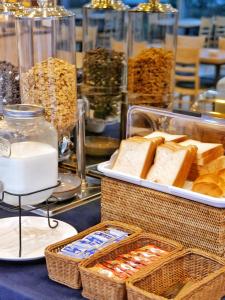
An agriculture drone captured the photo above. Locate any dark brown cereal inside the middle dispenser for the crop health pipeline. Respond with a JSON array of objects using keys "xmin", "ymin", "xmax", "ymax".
[{"xmin": 82, "ymin": 48, "xmax": 126, "ymax": 120}]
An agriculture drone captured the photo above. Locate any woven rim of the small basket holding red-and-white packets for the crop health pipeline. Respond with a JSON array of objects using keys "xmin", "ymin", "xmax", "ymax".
[{"xmin": 79, "ymin": 232, "xmax": 183, "ymax": 285}]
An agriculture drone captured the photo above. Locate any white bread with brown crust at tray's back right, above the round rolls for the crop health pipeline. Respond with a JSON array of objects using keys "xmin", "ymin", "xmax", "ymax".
[{"xmin": 179, "ymin": 139, "xmax": 224, "ymax": 165}]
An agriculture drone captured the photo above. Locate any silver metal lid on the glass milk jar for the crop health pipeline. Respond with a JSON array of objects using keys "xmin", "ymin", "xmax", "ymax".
[{"xmin": 3, "ymin": 104, "xmax": 45, "ymax": 119}]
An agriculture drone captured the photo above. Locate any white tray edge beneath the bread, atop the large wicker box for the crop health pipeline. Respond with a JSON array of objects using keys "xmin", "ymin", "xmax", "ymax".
[{"xmin": 97, "ymin": 161, "xmax": 225, "ymax": 208}]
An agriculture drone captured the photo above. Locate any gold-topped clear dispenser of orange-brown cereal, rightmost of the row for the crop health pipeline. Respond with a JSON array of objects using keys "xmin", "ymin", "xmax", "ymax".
[{"xmin": 128, "ymin": 0, "xmax": 178, "ymax": 107}]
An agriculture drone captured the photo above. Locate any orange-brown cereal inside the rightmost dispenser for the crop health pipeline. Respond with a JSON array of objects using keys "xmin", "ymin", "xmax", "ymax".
[{"xmin": 128, "ymin": 48, "xmax": 174, "ymax": 106}]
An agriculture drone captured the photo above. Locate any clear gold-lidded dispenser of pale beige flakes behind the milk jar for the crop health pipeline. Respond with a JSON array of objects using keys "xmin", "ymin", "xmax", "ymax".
[{"xmin": 16, "ymin": 0, "xmax": 77, "ymax": 159}]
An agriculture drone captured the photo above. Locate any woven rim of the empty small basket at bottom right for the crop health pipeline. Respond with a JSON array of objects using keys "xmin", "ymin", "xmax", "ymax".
[{"xmin": 126, "ymin": 248, "xmax": 225, "ymax": 300}]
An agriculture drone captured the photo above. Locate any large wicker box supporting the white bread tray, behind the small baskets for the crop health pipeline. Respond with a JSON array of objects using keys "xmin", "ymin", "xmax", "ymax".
[{"xmin": 101, "ymin": 177, "xmax": 225, "ymax": 257}]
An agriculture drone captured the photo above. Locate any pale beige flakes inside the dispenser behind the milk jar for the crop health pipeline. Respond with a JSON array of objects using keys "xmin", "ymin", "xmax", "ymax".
[{"xmin": 21, "ymin": 57, "xmax": 77, "ymax": 136}]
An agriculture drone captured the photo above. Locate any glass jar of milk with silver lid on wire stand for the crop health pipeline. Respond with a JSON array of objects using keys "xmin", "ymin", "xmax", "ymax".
[{"xmin": 0, "ymin": 104, "xmax": 58, "ymax": 205}]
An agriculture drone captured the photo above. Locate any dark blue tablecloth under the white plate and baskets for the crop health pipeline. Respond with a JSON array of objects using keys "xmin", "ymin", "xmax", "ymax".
[{"xmin": 0, "ymin": 201, "xmax": 100, "ymax": 300}]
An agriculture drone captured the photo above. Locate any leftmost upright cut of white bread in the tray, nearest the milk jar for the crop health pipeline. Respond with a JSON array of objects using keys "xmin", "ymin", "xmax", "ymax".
[{"xmin": 112, "ymin": 137, "xmax": 164, "ymax": 179}]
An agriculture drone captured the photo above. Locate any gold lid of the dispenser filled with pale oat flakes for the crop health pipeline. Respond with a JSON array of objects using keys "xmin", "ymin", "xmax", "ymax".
[{"xmin": 17, "ymin": 0, "xmax": 75, "ymax": 19}]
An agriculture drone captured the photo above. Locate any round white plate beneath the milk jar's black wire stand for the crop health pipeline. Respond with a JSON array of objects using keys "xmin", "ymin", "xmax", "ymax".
[{"xmin": 0, "ymin": 216, "xmax": 77, "ymax": 261}]
